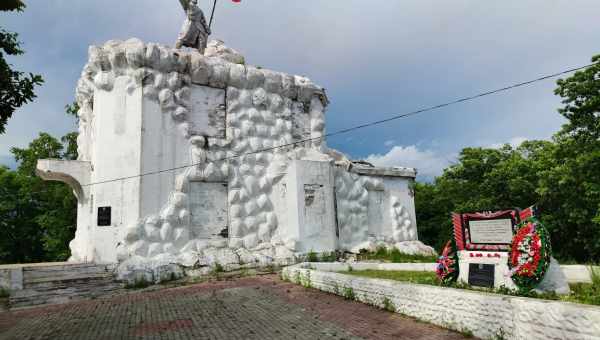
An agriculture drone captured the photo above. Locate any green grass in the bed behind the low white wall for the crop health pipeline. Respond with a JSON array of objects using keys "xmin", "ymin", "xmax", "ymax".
[{"xmin": 340, "ymin": 270, "xmax": 600, "ymax": 306}]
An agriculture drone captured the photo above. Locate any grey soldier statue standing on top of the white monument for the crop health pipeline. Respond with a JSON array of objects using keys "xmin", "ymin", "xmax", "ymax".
[{"xmin": 175, "ymin": 0, "xmax": 211, "ymax": 54}]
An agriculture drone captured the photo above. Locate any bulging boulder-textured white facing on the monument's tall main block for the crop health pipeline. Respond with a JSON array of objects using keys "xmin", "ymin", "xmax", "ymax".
[{"xmin": 73, "ymin": 39, "xmax": 330, "ymax": 276}]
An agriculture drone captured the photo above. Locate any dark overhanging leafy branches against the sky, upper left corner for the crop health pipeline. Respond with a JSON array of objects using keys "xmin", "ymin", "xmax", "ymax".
[{"xmin": 0, "ymin": 0, "xmax": 44, "ymax": 134}]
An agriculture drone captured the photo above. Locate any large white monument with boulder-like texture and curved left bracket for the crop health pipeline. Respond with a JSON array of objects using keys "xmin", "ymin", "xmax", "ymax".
[{"xmin": 38, "ymin": 39, "xmax": 433, "ymax": 280}]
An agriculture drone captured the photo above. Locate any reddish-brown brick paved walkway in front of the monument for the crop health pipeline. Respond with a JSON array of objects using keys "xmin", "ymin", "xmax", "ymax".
[{"xmin": 0, "ymin": 275, "xmax": 464, "ymax": 340}]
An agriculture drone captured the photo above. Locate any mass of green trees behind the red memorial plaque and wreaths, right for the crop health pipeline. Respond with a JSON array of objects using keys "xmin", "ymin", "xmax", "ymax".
[{"xmin": 415, "ymin": 56, "xmax": 600, "ymax": 262}]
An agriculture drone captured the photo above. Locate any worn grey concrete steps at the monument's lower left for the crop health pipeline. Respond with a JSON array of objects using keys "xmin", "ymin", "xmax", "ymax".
[{"xmin": 9, "ymin": 264, "xmax": 123, "ymax": 309}]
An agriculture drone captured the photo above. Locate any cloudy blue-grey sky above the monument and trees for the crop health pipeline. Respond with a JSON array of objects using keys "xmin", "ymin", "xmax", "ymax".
[{"xmin": 0, "ymin": 0, "xmax": 600, "ymax": 179}]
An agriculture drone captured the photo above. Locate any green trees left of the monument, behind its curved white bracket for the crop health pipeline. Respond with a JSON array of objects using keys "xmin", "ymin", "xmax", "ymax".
[{"xmin": 0, "ymin": 120, "xmax": 77, "ymax": 263}]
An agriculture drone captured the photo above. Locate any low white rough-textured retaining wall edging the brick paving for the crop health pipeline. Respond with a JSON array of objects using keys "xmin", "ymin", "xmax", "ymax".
[{"xmin": 283, "ymin": 264, "xmax": 600, "ymax": 339}]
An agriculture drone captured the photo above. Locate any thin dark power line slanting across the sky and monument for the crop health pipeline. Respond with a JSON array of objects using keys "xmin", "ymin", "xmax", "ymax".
[{"xmin": 35, "ymin": 63, "xmax": 596, "ymax": 187}]
